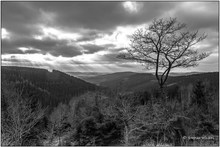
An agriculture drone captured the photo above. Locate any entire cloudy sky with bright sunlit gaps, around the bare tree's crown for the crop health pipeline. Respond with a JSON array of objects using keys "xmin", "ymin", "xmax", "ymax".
[{"xmin": 1, "ymin": 1, "xmax": 218, "ymax": 72}]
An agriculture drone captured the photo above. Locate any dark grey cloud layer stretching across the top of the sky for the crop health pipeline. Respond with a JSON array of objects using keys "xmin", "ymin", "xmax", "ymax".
[{"xmin": 2, "ymin": 1, "xmax": 218, "ymax": 41}]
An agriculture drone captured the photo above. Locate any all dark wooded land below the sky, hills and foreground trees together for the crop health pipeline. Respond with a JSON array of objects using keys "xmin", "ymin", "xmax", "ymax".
[{"xmin": 1, "ymin": 66, "xmax": 219, "ymax": 146}]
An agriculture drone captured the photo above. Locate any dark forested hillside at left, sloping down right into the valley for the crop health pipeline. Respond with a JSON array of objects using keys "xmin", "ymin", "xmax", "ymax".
[{"xmin": 1, "ymin": 66, "xmax": 98, "ymax": 106}]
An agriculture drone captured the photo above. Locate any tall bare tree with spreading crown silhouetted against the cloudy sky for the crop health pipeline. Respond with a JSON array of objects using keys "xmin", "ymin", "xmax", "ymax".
[{"xmin": 118, "ymin": 18, "xmax": 209, "ymax": 95}]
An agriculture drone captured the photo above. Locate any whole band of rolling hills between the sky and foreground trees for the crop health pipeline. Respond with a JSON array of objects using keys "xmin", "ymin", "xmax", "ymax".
[{"xmin": 1, "ymin": 66, "xmax": 219, "ymax": 106}]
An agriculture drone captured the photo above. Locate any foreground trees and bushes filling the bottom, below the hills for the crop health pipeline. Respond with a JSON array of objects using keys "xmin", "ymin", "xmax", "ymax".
[{"xmin": 1, "ymin": 70, "xmax": 219, "ymax": 146}]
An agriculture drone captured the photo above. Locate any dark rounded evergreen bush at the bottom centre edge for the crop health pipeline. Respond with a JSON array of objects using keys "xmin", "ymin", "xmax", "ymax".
[{"xmin": 72, "ymin": 105, "xmax": 122, "ymax": 146}]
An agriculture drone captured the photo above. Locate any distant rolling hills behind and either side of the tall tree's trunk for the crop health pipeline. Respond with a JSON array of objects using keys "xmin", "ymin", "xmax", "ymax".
[{"xmin": 84, "ymin": 72, "xmax": 219, "ymax": 92}]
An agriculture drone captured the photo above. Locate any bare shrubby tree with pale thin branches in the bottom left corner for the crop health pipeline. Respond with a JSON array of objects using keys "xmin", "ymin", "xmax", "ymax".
[{"xmin": 1, "ymin": 82, "xmax": 45, "ymax": 146}]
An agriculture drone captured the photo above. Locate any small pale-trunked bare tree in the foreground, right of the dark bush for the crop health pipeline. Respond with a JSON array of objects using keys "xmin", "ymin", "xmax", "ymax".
[{"xmin": 102, "ymin": 98, "xmax": 146, "ymax": 146}]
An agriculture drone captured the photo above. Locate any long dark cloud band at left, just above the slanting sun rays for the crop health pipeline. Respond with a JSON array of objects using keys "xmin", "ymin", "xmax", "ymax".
[{"xmin": 2, "ymin": 37, "xmax": 117, "ymax": 57}]
